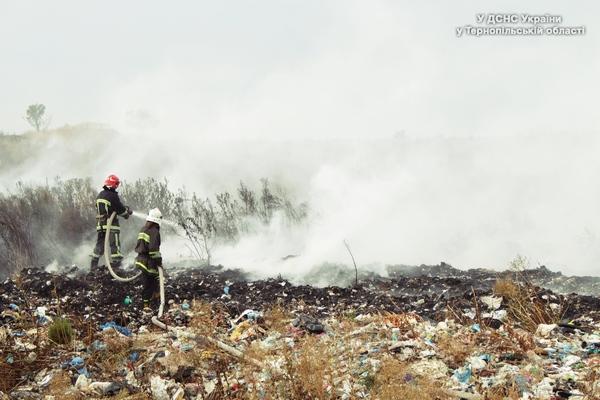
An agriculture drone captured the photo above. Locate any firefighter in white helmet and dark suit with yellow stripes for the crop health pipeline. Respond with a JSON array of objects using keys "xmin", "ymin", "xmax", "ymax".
[{"xmin": 135, "ymin": 208, "xmax": 162, "ymax": 309}]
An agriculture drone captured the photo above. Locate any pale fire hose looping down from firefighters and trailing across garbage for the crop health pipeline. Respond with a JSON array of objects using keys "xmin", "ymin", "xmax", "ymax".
[{"xmin": 104, "ymin": 212, "xmax": 264, "ymax": 368}]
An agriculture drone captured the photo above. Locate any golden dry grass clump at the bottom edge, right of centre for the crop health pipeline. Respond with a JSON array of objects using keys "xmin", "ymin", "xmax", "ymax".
[{"xmin": 370, "ymin": 358, "xmax": 453, "ymax": 400}]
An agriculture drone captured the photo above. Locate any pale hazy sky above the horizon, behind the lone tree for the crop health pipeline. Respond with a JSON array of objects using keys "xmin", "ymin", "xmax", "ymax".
[{"xmin": 0, "ymin": 0, "xmax": 600, "ymax": 138}]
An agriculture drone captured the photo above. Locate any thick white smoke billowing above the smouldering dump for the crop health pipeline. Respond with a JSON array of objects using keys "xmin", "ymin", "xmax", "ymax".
[{"xmin": 2, "ymin": 1, "xmax": 600, "ymax": 275}]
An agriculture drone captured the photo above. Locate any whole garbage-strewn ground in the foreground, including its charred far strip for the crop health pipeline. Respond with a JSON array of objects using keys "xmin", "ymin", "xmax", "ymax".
[{"xmin": 0, "ymin": 269, "xmax": 600, "ymax": 400}]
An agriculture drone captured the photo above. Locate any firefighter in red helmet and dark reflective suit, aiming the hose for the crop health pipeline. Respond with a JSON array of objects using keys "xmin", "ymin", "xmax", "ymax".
[{"xmin": 90, "ymin": 175, "xmax": 133, "ymax": 272}]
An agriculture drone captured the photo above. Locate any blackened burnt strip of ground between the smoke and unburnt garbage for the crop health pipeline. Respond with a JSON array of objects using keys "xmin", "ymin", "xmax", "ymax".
[{"xmin": 0, "ymin": 263, "xmax": 600, "ymax": 326}]
